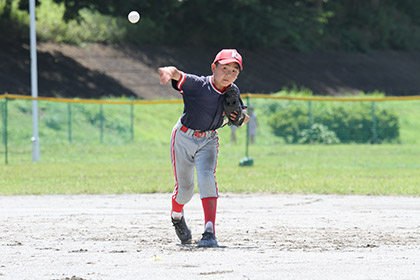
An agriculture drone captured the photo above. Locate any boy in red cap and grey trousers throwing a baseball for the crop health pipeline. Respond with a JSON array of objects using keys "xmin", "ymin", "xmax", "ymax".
[{"xmin": 158, "ymin": 49, "xmax": 249, "ymax": 247}]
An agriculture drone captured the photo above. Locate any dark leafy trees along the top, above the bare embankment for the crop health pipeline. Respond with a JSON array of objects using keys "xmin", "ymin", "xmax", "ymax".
[{"xmin": 0, "ymin": 0, "xmax": 420, "ymax": 52}]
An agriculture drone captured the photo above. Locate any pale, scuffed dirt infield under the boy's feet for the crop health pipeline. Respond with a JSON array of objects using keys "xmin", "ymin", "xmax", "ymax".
[{"xmin": 0, "ymin": 194, "xmax": 420, "ymax": 280}]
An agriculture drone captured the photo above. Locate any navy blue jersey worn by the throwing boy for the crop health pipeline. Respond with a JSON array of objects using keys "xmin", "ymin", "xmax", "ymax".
[{"xmin": 172, "ymin": 73, "xmax": 246, "ymax": 131}]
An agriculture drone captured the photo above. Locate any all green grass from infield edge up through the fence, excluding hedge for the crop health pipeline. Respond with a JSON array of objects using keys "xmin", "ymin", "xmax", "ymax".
[{"xmin": 0, "ymin": 95, "xmax": 420, "ymax": 196}]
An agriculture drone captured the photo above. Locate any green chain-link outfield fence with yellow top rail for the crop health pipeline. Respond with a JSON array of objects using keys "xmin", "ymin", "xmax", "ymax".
[{"xmin": 0, "ymin": 94, "xmax": 420, "ymax": 162}]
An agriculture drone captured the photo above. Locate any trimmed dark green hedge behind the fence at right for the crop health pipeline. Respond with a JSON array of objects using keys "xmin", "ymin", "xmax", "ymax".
[{"xmin": 269, "ymin": 104, "xmax": 399, "ymax": 144}]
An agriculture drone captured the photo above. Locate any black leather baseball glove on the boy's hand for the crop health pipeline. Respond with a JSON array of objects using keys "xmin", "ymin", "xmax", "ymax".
[{"xmin": 223, "ymin": 86, "xmax": 245, "ymax": 126}]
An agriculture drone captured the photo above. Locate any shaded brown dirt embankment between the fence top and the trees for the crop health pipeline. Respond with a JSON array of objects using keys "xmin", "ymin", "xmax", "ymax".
[{"xmin": 0, "ymin": 43, "xmax": 420, "ymax": 99}]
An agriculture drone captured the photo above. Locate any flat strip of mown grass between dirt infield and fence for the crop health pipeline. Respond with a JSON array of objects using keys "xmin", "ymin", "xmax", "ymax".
[{"xmin": 0, "ymin": 143, "xmax": 420, "ymax": 196}]
